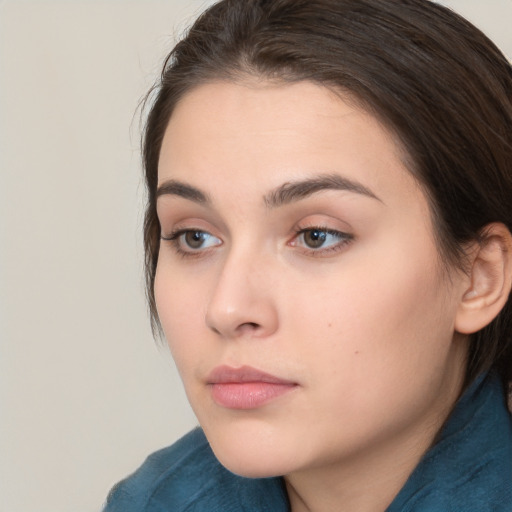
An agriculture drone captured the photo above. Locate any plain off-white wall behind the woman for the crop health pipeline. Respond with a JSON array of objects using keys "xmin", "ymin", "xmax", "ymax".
[{"xmin": 0, "ymin": 0, "xmax": 512, "ymax": 512}]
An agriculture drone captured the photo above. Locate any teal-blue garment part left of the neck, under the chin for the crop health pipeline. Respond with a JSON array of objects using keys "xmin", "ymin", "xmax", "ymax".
[{"xmin": 103, "ymin": 429, "xmax": 287, "ymax": 512}]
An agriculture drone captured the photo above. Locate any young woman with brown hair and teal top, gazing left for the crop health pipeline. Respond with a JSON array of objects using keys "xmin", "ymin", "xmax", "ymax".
[{"xmin": 105, "ymin": 0, "xmax": 512, "ymax": 512}]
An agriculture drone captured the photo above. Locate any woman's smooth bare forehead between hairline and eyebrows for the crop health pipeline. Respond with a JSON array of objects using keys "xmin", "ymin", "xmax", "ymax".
[{"xmin": 158, "ymin": 81, "xmax": 423, "ymax": 210}]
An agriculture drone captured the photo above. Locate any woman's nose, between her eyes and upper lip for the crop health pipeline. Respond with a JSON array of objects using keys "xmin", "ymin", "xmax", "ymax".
[{"xmin": 206, "ymin": 248, "xmax": 278, "ymax": 339}]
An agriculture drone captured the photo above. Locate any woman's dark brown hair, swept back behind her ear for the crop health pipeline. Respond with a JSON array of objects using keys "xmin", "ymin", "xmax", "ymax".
[{"xmin": 143, "ymin": 0, "xmax": 512, "ymax": 383}]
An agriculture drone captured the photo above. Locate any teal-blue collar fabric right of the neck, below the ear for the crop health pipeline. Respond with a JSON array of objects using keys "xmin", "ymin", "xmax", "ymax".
[{"xmin": 387, "ymin": 374, "xmax": 512, "ymax": 512}]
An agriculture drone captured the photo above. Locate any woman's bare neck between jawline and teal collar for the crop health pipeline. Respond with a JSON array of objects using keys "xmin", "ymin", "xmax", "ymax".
[{"xmin": 285, "ymin": 352, "xmax": 463, "ymax": 512}]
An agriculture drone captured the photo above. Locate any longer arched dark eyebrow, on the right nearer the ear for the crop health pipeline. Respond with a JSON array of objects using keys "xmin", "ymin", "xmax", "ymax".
[{"xmin": 264, "ymin": 174, "xmax": 382, "ymax": 208}]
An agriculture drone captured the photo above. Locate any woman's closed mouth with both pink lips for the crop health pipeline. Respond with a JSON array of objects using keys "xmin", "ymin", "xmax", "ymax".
[{"xmin": 207, "ymin": 366, "xmax": 298, "ymax": 410}]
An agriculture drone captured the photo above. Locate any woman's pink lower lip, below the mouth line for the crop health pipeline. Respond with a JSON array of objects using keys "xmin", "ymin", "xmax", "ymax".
[{"xmin": 211, "ymin": 382, "xmax": 297, "ymax": 409}]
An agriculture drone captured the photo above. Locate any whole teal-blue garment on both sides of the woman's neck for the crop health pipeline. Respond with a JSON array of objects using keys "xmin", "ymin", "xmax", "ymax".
[{"xmin": 104, "ymin": 375, "xmax": 512, "ymax": 512}]
